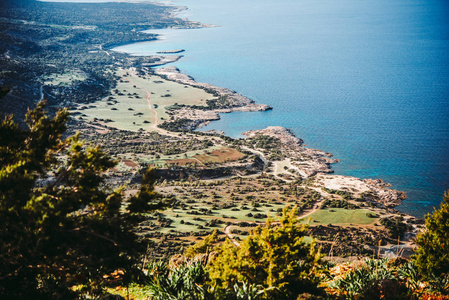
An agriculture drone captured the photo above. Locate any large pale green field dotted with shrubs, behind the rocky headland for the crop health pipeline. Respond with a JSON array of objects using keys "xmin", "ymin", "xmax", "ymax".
[{"xmin": 74, "ymin": 71, "xmax": 214, "ymax": 131}]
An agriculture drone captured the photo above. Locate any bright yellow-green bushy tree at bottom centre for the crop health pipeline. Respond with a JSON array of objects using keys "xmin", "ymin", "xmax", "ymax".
[{"xmin": 208, "ymin": 208, "xmax": 322, "ymax": 299}]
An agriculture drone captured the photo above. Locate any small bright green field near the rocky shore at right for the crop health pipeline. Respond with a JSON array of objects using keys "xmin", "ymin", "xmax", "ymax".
[{"xmin": 304, "ymin": 208, "xmax": 377, "ymax": 225}]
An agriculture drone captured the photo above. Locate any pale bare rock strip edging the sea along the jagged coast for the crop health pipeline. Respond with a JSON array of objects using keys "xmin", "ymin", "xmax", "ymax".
[{"xmin": 154, "ymin": 66, "xmax": 406, "ymax": 208}]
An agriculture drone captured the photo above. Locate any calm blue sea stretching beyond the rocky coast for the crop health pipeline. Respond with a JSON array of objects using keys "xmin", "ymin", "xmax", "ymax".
[{"xmin": 113, "ymin": 0, "xmax": 449, "ymax": 216}]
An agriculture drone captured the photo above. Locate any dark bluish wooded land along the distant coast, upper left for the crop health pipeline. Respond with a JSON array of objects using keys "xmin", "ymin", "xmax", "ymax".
[{"xmin": 0, "ymin": 0, "xmax": 199, "ymax": 117}]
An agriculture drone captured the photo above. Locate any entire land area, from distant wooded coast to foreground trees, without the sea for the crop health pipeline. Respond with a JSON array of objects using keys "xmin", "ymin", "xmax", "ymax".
[{"xmin": 0, "ymin": 0, "xmax": 449, "ymax": 299}]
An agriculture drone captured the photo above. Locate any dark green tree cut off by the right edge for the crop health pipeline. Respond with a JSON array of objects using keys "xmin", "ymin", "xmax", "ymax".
[{"xmin": 414, "ymin": 193, "xmax": 449, "ymax": 277}]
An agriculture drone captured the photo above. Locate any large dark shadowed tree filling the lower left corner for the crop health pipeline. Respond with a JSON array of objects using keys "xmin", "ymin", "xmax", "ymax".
[{"xmin": 0, "ymin": 102, "xmax": 165, "ymax": 299}]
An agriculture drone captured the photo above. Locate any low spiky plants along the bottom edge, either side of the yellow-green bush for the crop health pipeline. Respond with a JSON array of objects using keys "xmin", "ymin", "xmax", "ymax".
[{"xmin": 142, "ymin": 258, "xmax": 449, "ymax": 300}]
